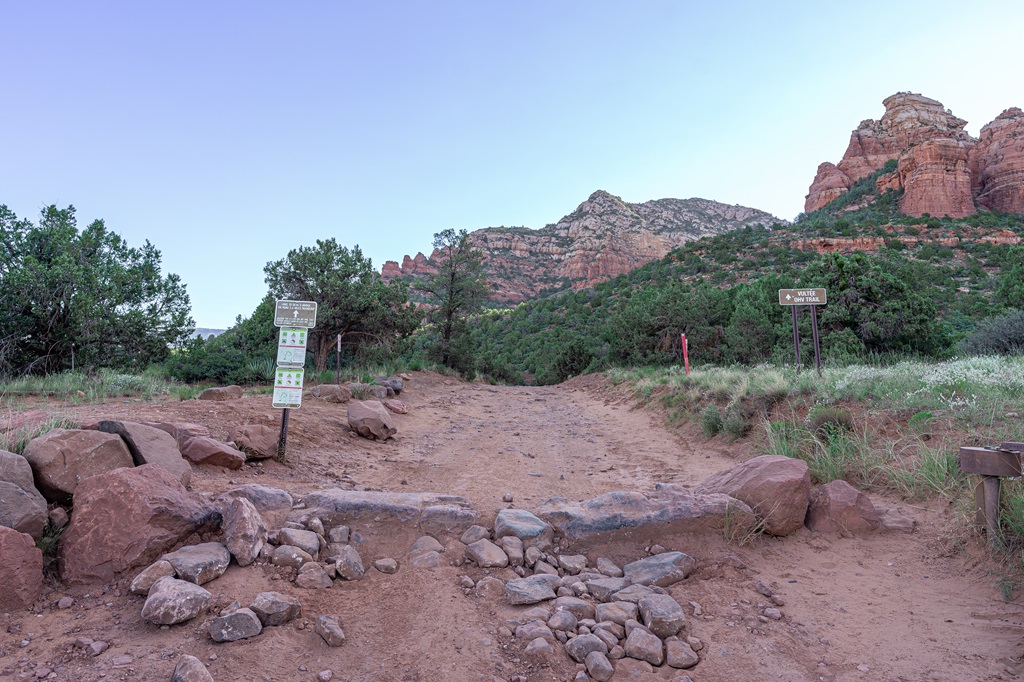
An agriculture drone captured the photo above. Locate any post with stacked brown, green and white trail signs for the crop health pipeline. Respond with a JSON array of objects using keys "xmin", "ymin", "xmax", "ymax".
[{"xmin": 273, "ymin": 300, "xmax": 316, "ymax": 462}]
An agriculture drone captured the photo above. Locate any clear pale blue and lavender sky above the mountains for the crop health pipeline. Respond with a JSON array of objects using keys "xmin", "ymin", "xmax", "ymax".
[{"xmin": 0, "ymin": 0, "xmax": 1024, "ymax": 328}]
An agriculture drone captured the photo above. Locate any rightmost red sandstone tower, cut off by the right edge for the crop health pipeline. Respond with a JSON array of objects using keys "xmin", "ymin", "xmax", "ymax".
[{"xmin": 971, "ymin": 106, "xmax": 1024, "ymax": 213}]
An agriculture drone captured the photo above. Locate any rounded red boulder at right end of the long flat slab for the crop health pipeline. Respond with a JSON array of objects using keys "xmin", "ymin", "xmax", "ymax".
[{"xmin": 695, "ymin": 455, "xmax": 811, "ymax": 536}]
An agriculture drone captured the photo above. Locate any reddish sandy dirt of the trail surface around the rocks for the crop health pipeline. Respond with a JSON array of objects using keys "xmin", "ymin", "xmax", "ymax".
[{"xmin": 0, "ymin": 374, "xmax": 1024, "ymax": 682}]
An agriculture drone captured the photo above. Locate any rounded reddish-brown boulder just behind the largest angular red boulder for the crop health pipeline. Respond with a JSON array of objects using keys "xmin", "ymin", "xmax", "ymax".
[{"xmin": 25, "ymin": 429, "xmax": 135, "ymax": 504}]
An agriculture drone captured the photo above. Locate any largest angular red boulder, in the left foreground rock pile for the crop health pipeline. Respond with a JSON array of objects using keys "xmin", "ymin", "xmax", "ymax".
[{"xmin": 59, "ymin": 464, "xmax": 221, "ymax": 583}]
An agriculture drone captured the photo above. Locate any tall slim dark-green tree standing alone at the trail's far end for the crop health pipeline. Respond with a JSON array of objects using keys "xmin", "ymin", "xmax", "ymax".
[{"xmin": 416, "ymin": 228, "xmax": 488, "ymax": 371}]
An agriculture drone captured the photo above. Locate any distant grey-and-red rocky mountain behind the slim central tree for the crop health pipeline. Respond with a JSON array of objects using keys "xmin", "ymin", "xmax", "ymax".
[{"xmin": 381, "ymin": 190, "xmax": 785, "ymax": 303}]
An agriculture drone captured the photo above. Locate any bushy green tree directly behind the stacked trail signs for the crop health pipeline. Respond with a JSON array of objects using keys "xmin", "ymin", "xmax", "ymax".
[{"xmin": 263, "ymin": 239, "xmax": 421, "ymax": 372}]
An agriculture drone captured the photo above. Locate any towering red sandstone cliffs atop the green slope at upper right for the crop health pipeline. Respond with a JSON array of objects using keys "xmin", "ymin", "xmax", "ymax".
[{"xmin": 804, "ymin": 92, "xmax": 1024, "ymax": 218}]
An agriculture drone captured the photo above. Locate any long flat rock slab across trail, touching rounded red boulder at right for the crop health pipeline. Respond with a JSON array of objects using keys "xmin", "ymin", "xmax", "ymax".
[{"xmin": 532, "ymin": 483, "xmax": 757, "ymax": 540}]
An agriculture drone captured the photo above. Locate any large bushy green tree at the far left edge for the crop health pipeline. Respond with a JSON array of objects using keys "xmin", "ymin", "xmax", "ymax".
[{"xmin": 0, "ymin": 206, "xmax": 195, "ymax": 374}]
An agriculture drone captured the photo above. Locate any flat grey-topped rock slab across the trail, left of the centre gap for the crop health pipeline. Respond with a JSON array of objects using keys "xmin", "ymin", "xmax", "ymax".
[{"xmin": 292, "ymin": 488, "xmax": 477, "ymax": 530}]
